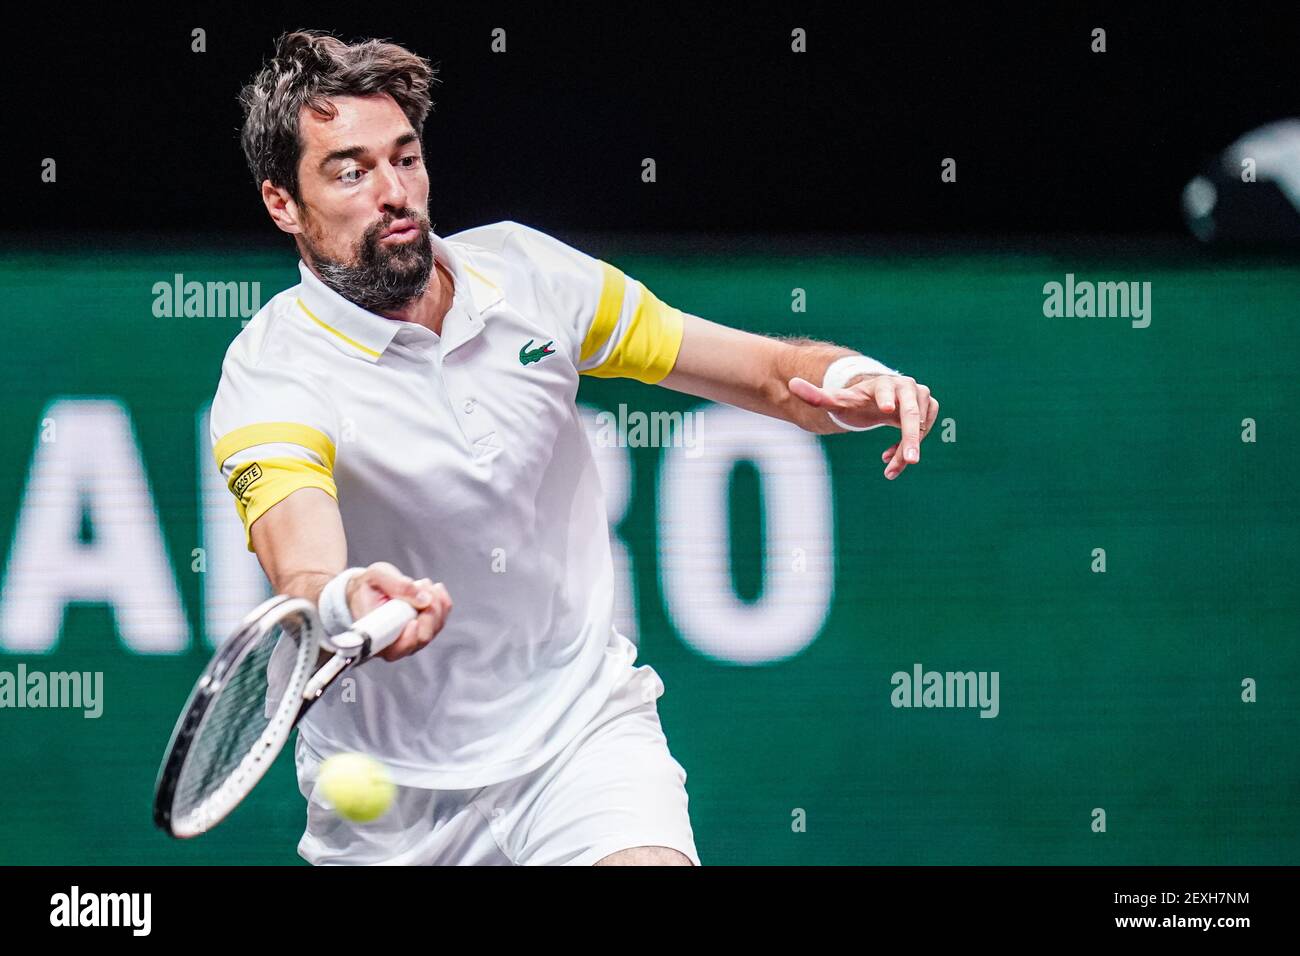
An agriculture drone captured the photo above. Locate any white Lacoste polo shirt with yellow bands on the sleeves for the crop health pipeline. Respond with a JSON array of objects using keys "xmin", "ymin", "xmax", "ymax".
[{"xmin": 211, "ymin": 222, "xmax": 683, "ymax": 790}]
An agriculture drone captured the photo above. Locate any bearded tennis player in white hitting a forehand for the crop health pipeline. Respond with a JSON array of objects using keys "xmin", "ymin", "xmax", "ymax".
[{"xmin": 212, "ymin": 33, "xmax": 939, "ymax": 865}]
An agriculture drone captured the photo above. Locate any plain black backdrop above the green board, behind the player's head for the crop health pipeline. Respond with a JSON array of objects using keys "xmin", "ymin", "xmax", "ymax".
[{"xmin": 0, "ymin": 3, "xmax": 1300, "ymax": 242}]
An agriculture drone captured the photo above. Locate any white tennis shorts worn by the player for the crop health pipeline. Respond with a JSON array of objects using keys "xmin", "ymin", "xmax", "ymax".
[{"xmin": 295, "ymin": 650, "xmax": 699, "ymax": 866}]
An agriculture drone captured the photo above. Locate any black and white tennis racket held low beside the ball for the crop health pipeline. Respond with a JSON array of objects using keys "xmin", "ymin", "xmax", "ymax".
[{"xmin": 153, "ymin": 594, "xmax": 416, "ymax": 838}]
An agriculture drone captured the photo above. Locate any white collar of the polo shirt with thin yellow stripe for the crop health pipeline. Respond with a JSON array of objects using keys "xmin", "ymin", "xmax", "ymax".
[{"xmin": 295, "ymin": 230, "xmax": 502, "ymax": 363}]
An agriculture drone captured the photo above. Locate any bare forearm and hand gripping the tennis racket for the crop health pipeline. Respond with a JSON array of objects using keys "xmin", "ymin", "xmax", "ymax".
[{"xmin": 250, "ymin": 488, "xmax": 451, "ymax": 661}]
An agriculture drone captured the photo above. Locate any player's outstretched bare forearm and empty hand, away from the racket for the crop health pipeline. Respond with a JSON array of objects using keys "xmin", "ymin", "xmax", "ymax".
[{"xmin": 658, "ymin": 312, "xmax": 939, "ymax": 479}]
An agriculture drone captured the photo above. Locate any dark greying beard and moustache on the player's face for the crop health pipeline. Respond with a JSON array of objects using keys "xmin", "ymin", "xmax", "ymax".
[{"xmin": 303, "ymin": 209, "xmax": 433, "ymax": 312}]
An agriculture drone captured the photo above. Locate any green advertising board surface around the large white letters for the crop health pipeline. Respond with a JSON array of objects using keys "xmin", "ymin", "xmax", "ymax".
[{"xmin": 0, "ymin": 243, "xmax": 1300, "ymax": 864}]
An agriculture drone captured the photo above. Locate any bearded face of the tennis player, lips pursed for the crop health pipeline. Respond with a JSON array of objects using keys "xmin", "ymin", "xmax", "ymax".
[{"xmin": 289, "ymin": 95, "xmax": 433, "ymax": 312}]
